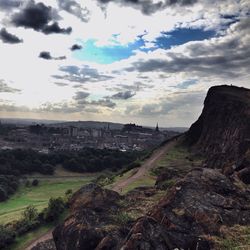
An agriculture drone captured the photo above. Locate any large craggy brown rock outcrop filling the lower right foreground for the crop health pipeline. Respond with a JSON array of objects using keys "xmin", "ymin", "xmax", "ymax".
[{"xmin": 122, "ymin": 168, "xmax": 250, "ymax": 250}]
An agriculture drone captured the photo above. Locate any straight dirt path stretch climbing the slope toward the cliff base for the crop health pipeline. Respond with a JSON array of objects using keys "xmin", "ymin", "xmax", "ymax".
[{"xmin": 112, "ymin": 140, "xmax": 177, "ymax": 193}]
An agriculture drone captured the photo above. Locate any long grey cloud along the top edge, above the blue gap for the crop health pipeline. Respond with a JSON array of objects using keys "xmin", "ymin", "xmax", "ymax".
[{"xmin": 97, "ymin": 0, "xmax": 198, "ymax": 15}]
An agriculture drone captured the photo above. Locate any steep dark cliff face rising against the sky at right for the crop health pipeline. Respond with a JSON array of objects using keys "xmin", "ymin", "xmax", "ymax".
[{"xmin": 187, "ymin": 85, "xmax": 250, "ymax": 168}]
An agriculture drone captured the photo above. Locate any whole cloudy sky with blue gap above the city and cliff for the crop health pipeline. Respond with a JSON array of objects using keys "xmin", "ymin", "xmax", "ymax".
[{"xmin": 0, "ymin": 0, "xmax": 250, "ymax": 127}]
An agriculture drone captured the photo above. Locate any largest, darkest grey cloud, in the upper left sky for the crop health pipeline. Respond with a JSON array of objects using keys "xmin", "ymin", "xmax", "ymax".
[{"xmin": 12, "ymin": 0, "xmax": 72, "ymax": 34}]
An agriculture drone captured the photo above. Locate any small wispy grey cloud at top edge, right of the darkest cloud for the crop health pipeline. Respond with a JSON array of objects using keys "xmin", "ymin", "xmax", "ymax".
[{"xmin": 57, "ymin": 0, "xmax": 90, "ymax": 22}]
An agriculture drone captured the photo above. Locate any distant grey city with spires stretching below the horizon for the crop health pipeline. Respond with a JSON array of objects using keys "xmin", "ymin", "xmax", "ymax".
[{"xmin": 0, "ymin": 120, "xmax": 184, "ymax": 154}]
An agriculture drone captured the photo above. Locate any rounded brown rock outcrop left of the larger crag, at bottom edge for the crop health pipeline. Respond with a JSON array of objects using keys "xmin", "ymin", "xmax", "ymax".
[{"xmin": 53, "ymin": 184, "xmax": 125, "ymax": 250}]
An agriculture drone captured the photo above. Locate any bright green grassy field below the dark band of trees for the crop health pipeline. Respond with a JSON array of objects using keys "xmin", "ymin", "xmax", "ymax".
[{"xmin": 0, "ymin": 176, "xmax": 94, "ymax": 224}]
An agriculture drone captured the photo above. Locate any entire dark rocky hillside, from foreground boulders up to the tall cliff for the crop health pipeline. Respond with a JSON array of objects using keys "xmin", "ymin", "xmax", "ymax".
[{"xmin": 34, "ymin": 86, "xmax": 250, "ymax": 250}]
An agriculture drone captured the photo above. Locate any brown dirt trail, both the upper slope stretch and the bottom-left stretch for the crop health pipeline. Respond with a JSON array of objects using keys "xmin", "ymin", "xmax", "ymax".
[{"xmin": 25, "ymin": 138, "xmax": 178, "ymax": 250}]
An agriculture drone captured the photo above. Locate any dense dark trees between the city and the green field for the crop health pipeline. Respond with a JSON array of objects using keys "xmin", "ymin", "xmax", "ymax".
[{"xmin": 0, "ymin": 148, "xmax": 145, "ymax": 201}]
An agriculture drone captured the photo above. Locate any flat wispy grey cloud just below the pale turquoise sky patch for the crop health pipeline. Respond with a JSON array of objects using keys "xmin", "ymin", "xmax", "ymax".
[{"xmin": 53, "ymin": 66, "xmax": 113, "ymax": 83}]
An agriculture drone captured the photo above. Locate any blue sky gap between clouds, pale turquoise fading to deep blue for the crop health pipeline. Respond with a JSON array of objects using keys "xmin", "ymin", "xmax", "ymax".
[{"xmin": 73, "ymin": 28, "xmax": 215, "ymax": 64}]
